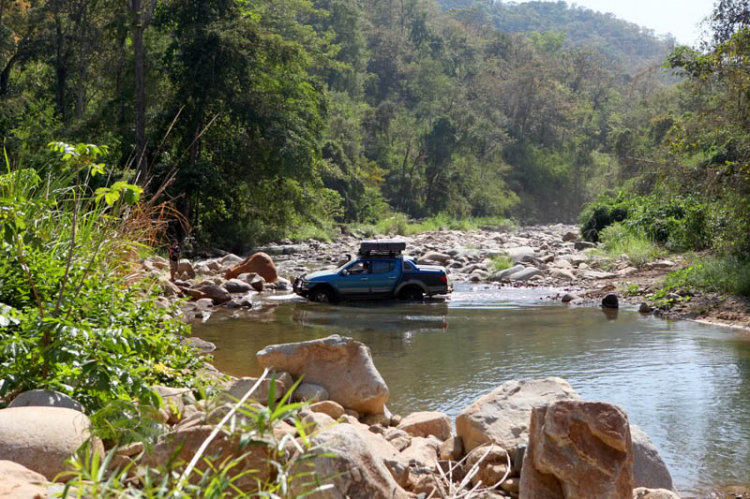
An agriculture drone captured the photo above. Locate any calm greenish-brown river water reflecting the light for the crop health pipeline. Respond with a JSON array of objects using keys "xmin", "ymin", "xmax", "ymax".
[{"xmin": 193, "ymin": 284, "xmax": 750, "ymax": 497}]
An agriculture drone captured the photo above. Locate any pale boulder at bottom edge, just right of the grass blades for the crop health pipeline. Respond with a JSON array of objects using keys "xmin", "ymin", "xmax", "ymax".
[{"xmin": 291, "ymin": 424, "xmax": 409, "ymax": 499}]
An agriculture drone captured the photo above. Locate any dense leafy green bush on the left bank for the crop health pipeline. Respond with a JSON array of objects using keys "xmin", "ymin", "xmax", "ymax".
[{"xmin": 0, "ymin": 143, "xmax": 204, "ymax": 410}]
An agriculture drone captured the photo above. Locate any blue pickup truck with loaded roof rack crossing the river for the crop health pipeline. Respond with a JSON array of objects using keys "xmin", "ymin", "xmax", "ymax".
[{"xmin": 294, "ymin": 241, "xmax": 453, "ymax": 303}]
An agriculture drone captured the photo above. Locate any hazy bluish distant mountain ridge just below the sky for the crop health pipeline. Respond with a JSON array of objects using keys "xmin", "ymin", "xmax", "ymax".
[{"xmin": 437, "ymin": 0, "xmax": 675, "ymax": 71}]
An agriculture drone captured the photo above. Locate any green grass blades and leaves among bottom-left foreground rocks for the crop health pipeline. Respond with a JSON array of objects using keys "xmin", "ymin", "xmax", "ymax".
[{"xmin": 60, "ymin": 376, "xmax": 333, "ymax": 498}]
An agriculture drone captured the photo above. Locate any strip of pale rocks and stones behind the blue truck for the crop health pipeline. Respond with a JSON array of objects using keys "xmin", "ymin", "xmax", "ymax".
[{"xmin": 141, "ymin": 224, "xmax": 750, "ymax": 330}]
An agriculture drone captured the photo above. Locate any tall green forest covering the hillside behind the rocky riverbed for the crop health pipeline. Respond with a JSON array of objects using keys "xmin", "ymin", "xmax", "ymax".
[{"xmin": 0, "ymin": 0, "xmax": 684, "ymax": 251}]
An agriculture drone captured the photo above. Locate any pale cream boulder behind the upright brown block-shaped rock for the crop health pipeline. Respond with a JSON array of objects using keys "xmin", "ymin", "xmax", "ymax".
[{"xmin": 456, "ymin": 378, "xmax": 580, "ymax": 459}]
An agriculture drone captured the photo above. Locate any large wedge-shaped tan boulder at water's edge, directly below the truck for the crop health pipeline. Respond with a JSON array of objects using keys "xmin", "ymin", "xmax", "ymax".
[{"xmin": 257, "ymin": 334, "xmax": 389, "ymax": 414}]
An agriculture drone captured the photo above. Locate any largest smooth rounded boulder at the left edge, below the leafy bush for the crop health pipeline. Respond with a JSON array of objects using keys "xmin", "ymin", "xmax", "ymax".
[{"xmin": 0, "ymin": 407, "xmax": 101, "ymax": 481}]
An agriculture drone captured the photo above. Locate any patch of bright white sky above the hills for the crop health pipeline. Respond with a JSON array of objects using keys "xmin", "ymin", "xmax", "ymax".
[{"xmin": 536, "ymin": 0, "xmax": 714, "ymax": 45}]
